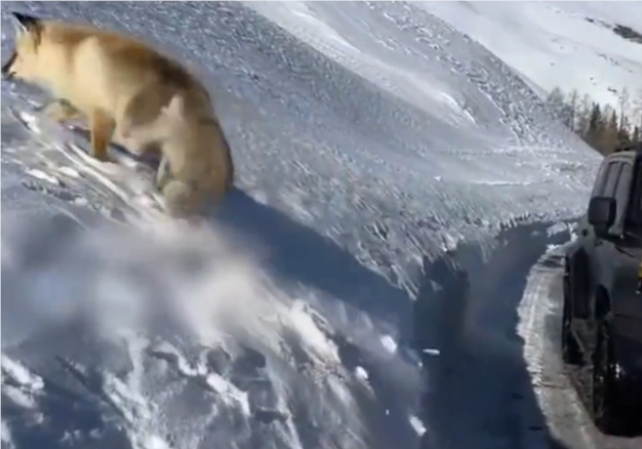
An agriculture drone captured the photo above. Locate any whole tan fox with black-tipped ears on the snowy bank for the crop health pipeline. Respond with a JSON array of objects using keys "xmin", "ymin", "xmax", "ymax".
[{"xmin": 2, "ymin": 13, "xmax": 234, "ymax": 216}]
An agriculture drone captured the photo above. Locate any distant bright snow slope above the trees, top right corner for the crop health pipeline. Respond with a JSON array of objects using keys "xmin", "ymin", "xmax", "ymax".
[{"xmin": 421, "ymin": 2, "xmax": 642, "ymax": 106}]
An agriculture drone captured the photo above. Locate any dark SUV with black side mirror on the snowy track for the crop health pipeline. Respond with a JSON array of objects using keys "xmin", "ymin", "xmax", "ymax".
[{"xmin": 561, "ymin": 144, "xmax": 642, "ymax": 434}]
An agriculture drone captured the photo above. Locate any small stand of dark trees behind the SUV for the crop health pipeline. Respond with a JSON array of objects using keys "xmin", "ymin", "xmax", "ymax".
[{"xmin": 546, "ymin": 87, "xmax": 642, "ymax": 155}]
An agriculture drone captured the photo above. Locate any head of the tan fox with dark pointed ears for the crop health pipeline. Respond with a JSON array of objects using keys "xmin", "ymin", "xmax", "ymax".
[{"xmin": 2, "ymin": 12, "xmax": 44, "ymax": 81}]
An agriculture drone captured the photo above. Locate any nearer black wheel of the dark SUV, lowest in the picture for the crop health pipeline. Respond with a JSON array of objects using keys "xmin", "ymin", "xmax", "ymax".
[{"xmin": 591, "ymin": 319, "xmax": 636, "ymax": 434}]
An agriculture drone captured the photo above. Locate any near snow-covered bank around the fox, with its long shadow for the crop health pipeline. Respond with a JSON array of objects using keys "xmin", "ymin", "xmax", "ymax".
[{"xmin": 2, "ymin": 2, "xmax": 599, "ymax": 449}]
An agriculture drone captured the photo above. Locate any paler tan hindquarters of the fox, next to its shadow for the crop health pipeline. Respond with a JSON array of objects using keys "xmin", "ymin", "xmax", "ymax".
[{"xmin": 122, "ymin": 92, "xmax": 234, "ymax": 217}]
